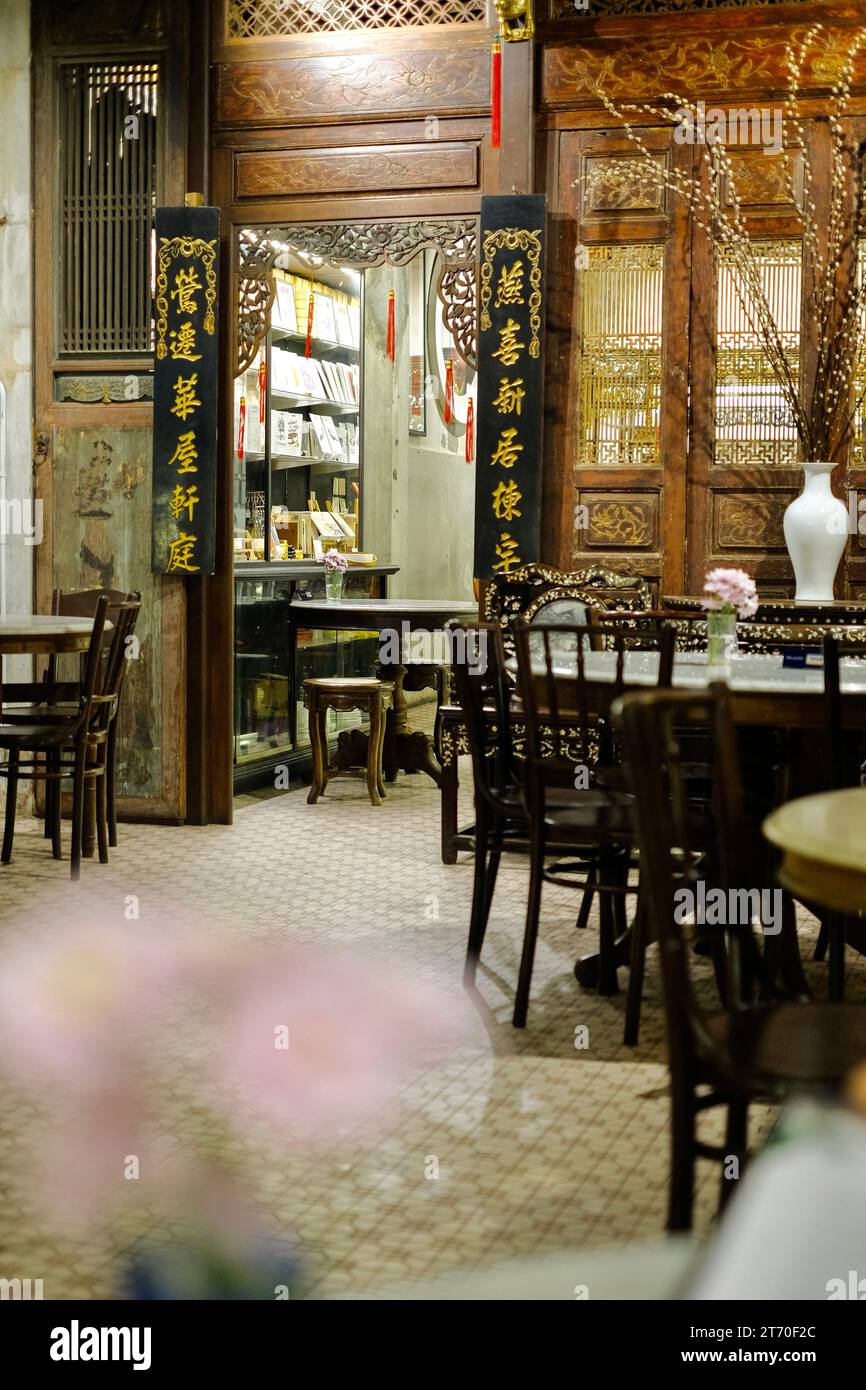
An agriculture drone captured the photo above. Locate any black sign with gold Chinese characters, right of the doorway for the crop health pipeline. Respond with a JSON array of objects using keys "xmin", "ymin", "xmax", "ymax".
[{"xmin": 474, "ymin": 196, "xmax": 545, "ymax": 580}]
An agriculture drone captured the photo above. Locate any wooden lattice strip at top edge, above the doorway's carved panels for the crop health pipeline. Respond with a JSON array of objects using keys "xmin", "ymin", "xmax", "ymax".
[{"xmin": 228, "ymin": 0, "xmax": 487, "ymax": 39}]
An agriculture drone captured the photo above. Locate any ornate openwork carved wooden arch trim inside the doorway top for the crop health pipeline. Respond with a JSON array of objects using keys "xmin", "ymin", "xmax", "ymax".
[{"xmin": 236, "ymin": 217, "xmax": 478, "ymax": 375}]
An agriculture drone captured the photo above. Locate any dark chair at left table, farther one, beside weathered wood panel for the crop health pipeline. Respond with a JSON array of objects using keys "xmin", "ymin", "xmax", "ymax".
[{"xmin": 3, "ymin": 589, "xmax": 142, "ymax": 849}]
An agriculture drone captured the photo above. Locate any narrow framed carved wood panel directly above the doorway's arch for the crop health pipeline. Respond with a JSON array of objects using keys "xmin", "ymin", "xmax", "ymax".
[{"xmin": 235, "ymin": 142, "xmax": 478, "ymax": 199}]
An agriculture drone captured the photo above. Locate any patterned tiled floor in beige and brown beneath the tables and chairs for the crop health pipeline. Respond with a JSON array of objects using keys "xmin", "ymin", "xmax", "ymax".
[{"xmin": 0, "ymin": 728, "xmax": 863, "ymax": 1297}]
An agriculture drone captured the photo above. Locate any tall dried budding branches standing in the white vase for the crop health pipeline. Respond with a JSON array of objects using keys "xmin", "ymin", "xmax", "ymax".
[{"xmin": 589, "ymin": 24, "xmax": 866, "ymax": 460}]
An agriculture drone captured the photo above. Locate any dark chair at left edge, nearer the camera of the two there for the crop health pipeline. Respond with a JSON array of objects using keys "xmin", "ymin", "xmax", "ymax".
[{"xmin": 0, "ymin": 595, "xmax": 117, "ymax": 878}]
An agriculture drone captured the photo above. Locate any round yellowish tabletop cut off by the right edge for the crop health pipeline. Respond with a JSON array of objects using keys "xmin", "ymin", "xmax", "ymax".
[{"xmin": 763, "ymin": 787, "xmax": 866, "ymax": 913}]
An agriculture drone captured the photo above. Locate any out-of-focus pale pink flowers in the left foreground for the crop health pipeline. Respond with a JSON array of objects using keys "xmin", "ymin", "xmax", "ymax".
[{"xmin": 0, "ymin": 913, "xmax": 460, "ymax": 1215}]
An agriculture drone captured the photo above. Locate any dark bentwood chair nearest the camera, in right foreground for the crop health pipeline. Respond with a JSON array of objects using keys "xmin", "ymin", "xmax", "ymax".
[{"xmin": 614, "ymin": 687, "xmax": 866, "ymax": 1230}]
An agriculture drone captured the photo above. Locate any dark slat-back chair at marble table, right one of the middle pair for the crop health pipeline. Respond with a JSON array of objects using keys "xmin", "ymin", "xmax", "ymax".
[{"xmin": 513, "ymin": 623, "xmax": 674, "ymax": 1027}]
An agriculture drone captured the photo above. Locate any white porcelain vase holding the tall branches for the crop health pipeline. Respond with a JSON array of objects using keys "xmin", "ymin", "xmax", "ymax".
[{"xmin": 784, "ymin": 463, "xmax": 848, "ymax": 603}]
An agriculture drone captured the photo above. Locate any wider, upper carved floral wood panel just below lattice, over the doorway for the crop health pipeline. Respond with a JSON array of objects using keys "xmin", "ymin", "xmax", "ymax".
[{"xmin": 217, "ymin": 44, "xmax": 491, "ymax": 126}]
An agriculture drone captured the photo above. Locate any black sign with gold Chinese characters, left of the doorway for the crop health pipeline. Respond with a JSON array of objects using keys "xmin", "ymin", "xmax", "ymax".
[{"xmin": 152, "ymin": 207, "xmax": 220, "ymax": 575}]
